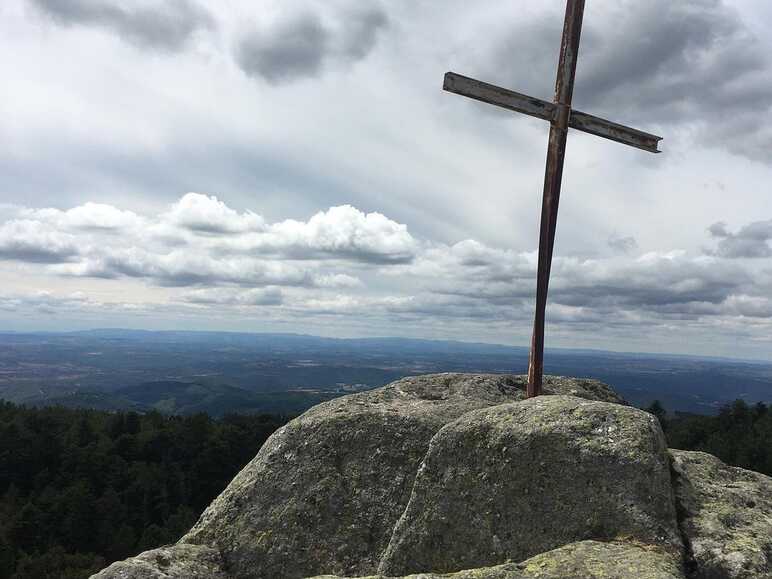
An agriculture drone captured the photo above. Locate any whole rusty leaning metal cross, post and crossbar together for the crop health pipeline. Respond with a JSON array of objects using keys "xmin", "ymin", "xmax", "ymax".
[{"xmin": 443, "ymin": 0, "xmax": 662, "ymax": 398}]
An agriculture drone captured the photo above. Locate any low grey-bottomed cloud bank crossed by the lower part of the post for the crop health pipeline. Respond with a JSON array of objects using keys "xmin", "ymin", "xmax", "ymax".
[{"xmin": 414, "ymin": 244, "xmax": 767, "ymax": 324}]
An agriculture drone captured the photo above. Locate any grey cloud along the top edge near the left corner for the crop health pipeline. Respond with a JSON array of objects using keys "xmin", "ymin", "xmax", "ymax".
[{"xmin": 29, "ymin": 0, "xmax": 214, "ymax": 51}]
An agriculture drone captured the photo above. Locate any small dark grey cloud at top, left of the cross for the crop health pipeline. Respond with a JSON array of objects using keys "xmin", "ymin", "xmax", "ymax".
[{"xmin": 235, "ymin": 4, "xmax": 388, "ymax": 84}]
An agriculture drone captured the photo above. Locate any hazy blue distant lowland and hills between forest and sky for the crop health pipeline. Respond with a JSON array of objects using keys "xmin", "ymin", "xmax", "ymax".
[{"xmin": 0, "ymin": 329, "xmax": 772, "ymax": 415}]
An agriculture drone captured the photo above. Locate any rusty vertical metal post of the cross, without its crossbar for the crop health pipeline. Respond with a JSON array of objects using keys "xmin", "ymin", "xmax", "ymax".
[{"xmin": 527, "ymin": 0, "xmax": 584, "ymax": 398}]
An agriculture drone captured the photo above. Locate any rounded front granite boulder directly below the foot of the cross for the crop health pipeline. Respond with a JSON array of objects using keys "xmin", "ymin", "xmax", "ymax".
[{"xmin": 379, "ymin": 396, "xmax": 682, "ymax": 575}]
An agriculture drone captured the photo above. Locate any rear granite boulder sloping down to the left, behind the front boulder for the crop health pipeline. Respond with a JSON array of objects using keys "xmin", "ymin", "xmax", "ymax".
[{"xmin": 183, "ymin": 374, "xmax": 622, "ymax": 578}]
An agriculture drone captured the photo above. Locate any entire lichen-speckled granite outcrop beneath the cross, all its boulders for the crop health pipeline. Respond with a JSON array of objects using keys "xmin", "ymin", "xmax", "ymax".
[{"xmin": 93, "ymin": 374, "xmax": 772, "ymax": 579}]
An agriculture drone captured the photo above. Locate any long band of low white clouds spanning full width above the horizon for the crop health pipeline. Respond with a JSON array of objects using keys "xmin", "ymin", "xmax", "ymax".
[{"xmin": 0, "ymin": 193, "xmax": 772, "ymax": 354}]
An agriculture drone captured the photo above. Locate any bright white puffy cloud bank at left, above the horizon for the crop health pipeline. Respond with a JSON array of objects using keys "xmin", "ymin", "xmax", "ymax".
[{"xmin": 0, "ymin": 193, "xmax": 418, "ymax": 289}]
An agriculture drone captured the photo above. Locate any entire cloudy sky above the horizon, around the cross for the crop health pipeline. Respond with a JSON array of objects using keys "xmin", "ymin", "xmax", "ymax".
[{"xmin": 0, "ymin": 0, "xmax": 772, "ymax": 360}]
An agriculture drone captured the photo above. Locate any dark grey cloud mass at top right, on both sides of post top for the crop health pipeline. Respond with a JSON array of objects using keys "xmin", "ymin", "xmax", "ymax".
[{"xmin": 479, "ymin": 0, "xmax": 772, "ymax": 163}]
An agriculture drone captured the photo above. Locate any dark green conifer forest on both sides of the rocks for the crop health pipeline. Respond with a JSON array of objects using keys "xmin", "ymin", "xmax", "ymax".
[{"xmin": 0, "ymin": 400, "xmax": 772, "ymax": 579}]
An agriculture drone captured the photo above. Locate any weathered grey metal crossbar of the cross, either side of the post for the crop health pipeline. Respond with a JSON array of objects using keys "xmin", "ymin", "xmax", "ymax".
[{"xmin": 442, "ymin": 72, "xmax": 662, "ymax": 153}]
